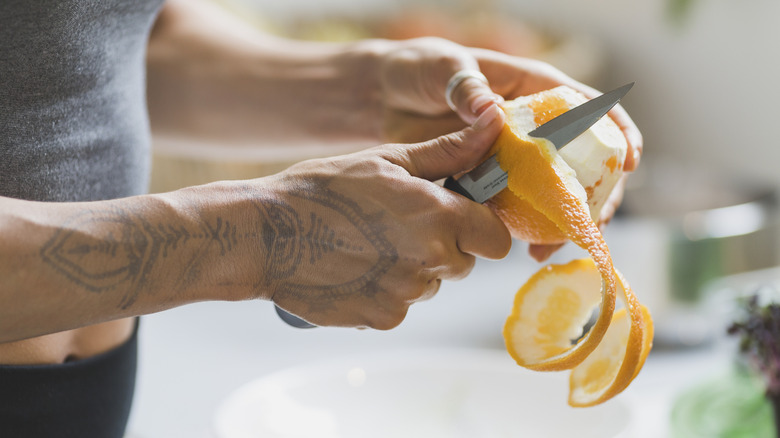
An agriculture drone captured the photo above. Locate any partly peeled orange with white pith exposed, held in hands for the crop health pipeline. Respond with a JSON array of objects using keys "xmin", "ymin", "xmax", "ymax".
[{"xmin": 487, "ymin": 86, "xmax": 628, "ymax": 244}]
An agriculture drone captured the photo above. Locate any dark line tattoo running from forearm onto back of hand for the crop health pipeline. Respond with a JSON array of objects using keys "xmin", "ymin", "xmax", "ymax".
[{"xmin": 40, "ymin": 181, "xmax": 398, "ymax": 312}]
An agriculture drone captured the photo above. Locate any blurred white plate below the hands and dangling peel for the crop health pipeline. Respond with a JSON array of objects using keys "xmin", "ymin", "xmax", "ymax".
[{"xmin": 214, "ymin": 350, "xmax": 629, "ymax": 438}]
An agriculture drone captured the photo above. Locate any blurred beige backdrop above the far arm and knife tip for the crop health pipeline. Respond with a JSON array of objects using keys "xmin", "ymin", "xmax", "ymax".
[{"xmin": 151, "ymin": 0, "xmax": 780, "ymax": 192}]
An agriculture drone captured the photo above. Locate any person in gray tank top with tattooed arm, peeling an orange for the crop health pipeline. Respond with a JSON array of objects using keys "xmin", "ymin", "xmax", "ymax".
[{"xmin": 0, "ymin": 0, "xmax": 642, "ymax": 437}]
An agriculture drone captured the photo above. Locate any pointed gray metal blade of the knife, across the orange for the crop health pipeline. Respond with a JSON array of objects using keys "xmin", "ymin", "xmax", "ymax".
[{"xmin": 528, "ymin": 82, "xmax": 634, "ymax": 149}]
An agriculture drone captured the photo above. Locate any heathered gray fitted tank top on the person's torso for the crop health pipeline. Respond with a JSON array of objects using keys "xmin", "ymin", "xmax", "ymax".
[{"xmin": 0, "ymin": 0, "xmax": 162, "ymax": 201}]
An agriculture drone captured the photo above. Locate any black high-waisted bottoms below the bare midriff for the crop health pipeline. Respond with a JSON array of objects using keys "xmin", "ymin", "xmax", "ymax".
[{"xmin": 0, "ymin": 321, "xmax": 138, "ymax": 438}]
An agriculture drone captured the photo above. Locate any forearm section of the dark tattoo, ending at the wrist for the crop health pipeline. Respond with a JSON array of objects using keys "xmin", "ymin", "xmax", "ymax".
[{"xmin": 40, "ymin": 207, "xmax": 237, "ymax": 309}]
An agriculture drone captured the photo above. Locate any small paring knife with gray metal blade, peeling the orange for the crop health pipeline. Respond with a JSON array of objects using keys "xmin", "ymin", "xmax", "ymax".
[{"xmin": 444, "ymin": 82, "xmax": 634, "ymax": 204}]
